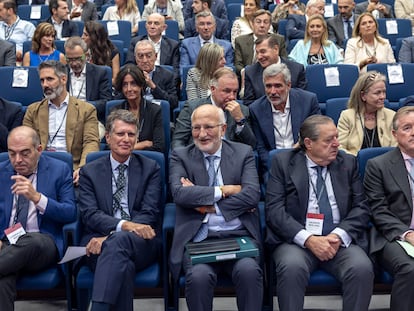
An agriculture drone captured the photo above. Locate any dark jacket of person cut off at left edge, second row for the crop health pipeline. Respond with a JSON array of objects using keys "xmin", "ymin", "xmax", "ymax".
[{"xmin": 0, "ymin": 98, "xmax": 24, "ymax": 152}]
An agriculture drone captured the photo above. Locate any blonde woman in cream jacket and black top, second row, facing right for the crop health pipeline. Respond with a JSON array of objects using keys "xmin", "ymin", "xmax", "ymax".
[{"xmin": 338, "ymin": 71, "xmax": 396, "ymax": 155}]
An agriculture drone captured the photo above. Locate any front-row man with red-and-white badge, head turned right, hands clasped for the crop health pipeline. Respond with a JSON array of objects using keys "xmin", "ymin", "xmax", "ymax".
[{"xmin": 266, "ymin": 115, "xmax": 374, "ymax": 311}]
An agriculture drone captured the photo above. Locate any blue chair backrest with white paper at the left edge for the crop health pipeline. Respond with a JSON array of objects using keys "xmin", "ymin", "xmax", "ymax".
[{"xmin": 0, "ymin": 67, "xmax": 43, "ymax": 106}]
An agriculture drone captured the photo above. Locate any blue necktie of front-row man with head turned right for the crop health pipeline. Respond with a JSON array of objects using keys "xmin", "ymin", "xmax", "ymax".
[{"xmin": 314, "ymin": 166, "xmax": 334, "ymax": 235}]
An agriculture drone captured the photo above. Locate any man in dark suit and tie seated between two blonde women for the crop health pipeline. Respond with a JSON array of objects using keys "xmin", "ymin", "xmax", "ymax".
[{"xmin": 326, "ymin": 0, "xmax": 359, "ymax": 49}]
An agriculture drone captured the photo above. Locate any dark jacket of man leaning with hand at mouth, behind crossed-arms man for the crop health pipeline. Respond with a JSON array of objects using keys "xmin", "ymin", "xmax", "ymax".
[{"xmin": 171, "ymin": 97, "xmax": 256, "ymax": 149}]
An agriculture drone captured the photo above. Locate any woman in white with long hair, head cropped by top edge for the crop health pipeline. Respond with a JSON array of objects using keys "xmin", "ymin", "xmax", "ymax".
[{"xmin": 102, "ymin": 0, "xmax": 141, "ymax": 36}]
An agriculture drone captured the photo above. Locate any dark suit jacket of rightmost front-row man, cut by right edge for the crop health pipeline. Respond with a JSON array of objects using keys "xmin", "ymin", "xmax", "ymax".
[{"xmin": 364, "ymin": 148, "xmax": 413, "ymax": 253}]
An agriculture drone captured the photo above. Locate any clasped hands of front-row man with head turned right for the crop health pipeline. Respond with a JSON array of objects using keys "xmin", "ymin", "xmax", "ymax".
[{"xmin": 305, "ymin": 234, "xmax": 341, "ymax": 261}]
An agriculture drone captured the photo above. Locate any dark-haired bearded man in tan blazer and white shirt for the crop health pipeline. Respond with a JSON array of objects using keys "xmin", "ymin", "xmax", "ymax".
[{"xmin": 23, "ymin": 61, "xmax": 99, "ymax": 183}]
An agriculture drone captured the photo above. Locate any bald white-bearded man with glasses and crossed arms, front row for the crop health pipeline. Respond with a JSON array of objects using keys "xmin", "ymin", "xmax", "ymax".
[{"xmin": 170, "ymin": 105, "xmax": 263, "ymax": 311}]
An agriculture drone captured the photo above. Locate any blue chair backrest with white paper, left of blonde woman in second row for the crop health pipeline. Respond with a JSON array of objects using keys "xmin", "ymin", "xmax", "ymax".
[{"xmin": 306, "ymin": 64, "xmax": 359, "ymax": 103}]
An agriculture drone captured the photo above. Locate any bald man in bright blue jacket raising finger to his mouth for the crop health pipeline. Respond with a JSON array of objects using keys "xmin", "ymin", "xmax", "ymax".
[{"xmin": 0, "ymin": 126, "xmax": 76, "ymax": 310}]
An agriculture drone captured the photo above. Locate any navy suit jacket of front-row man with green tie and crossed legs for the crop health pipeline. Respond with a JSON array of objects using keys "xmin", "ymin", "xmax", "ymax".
[{"xmin": 78, "ymin": 154, "xmax": 161, "ymax": 246}]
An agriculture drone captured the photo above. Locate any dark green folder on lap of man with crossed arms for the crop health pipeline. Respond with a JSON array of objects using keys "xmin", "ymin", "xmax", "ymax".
[{"xmin": 186, "ymin": 236, "xmax": 259, "ymax": 265}]
